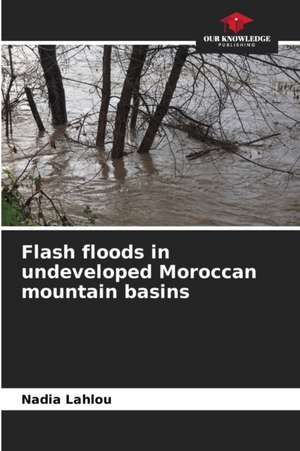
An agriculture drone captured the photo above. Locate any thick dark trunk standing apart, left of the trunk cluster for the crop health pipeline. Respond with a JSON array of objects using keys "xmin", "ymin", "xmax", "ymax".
[{"xmin": 39, "ymin": 45, "xmax": 68, "ymax": 125}]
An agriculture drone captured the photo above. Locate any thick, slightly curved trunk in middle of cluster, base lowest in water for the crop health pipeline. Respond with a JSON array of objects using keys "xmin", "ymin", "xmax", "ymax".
[{"xmin": 111, "ymin": 45, "xmax": 148, "ymax": 158}]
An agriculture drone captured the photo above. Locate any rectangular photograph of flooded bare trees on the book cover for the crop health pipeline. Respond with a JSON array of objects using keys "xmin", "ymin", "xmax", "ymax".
[{"xmin": 2, "ymin": 43, "xmax": 300, "ymax": 226}]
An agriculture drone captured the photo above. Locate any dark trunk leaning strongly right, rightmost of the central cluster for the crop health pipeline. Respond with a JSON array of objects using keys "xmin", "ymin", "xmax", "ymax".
[{"xmin": 138, "ymin": 46, "xmax": 188, "ymax": 153}]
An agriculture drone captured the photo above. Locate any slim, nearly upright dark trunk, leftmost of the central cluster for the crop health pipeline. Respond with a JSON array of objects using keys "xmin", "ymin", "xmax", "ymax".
[{"xmin": 96, "ymin": 45, "xmax": 112, "ymax": 149}]
